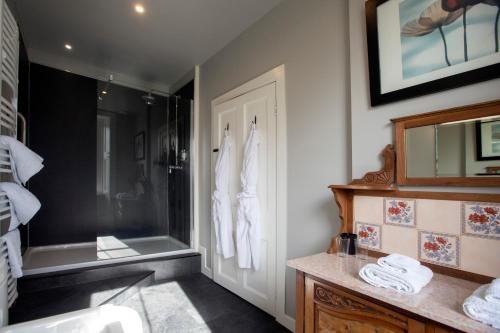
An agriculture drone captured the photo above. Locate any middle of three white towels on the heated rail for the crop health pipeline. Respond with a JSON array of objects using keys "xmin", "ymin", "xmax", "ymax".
[{"xmin": 0, "ymin": 183, "xmax": 42, "ymax": 231}]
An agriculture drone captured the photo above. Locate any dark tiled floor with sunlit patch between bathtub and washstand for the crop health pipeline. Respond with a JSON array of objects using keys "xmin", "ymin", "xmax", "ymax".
[{"xmin": 122, "ymin": 274, "xmax": 289, "ymax": 333}]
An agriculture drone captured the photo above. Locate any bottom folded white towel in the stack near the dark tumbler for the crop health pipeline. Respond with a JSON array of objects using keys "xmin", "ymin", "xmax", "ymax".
[{"xmin": 359, "ymin": 264, "xmax": 433, "ymax": 294}]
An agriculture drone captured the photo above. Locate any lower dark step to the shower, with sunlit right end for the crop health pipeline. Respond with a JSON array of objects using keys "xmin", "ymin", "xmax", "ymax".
[{"xmin": 9, "ymin": 271, "xmax": 154, "ymax": 324}]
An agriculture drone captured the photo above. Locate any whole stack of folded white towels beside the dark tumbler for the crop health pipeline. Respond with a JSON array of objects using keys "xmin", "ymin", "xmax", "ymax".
[{"xmin": 359, "ymin": 253, "xmax": 433, "ymax": 294}]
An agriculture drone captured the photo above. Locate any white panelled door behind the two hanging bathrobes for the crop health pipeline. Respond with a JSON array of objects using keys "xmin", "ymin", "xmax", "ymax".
[{"xmin": 212, "ymin": 83, "xmax": 277, "ymax": 315}]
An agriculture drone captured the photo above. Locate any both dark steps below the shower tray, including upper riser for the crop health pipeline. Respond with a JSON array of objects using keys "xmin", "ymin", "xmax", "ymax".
[{"xmin": 9, "ymin": 253, "xmax": 201, "ymax": 324}]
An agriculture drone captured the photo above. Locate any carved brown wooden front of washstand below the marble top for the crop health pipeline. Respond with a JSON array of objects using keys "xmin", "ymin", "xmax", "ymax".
[{"xmin": 305, "ymin": 278, "xmax": 425, "ymax": 333}]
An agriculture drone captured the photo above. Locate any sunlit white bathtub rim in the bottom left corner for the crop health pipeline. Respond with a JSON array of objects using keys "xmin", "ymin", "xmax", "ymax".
[{"xmin": 0, "ymin": 305, "xmax": 143, "ymax": 333}]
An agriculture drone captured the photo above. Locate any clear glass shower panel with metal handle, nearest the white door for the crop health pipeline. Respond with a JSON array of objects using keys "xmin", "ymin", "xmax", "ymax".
[{"xmin": 96, "ymin": 82, "xmax": 192, "ymax": 260}]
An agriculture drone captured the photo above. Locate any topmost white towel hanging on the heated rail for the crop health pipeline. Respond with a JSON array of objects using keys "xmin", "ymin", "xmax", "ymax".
[{"xmin": 0, "ymin": 135, "xmax": 43, "ymax": 184}]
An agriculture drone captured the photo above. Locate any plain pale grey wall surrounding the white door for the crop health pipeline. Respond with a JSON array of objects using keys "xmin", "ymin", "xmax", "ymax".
[{"xmin": 199, "ymin": 0, "xmax": 350, "ymax": 316}]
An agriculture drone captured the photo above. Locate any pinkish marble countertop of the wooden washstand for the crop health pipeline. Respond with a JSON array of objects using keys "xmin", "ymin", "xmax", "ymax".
[{"xmin": 287, "ymin": 253, "xmax": 500, "ymax": 333}]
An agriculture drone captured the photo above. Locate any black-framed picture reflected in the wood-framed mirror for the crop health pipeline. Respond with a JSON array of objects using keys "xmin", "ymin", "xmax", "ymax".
[{"xmin": 476, "ymin": 118, "xmax": 500, "ymax": 161}]
